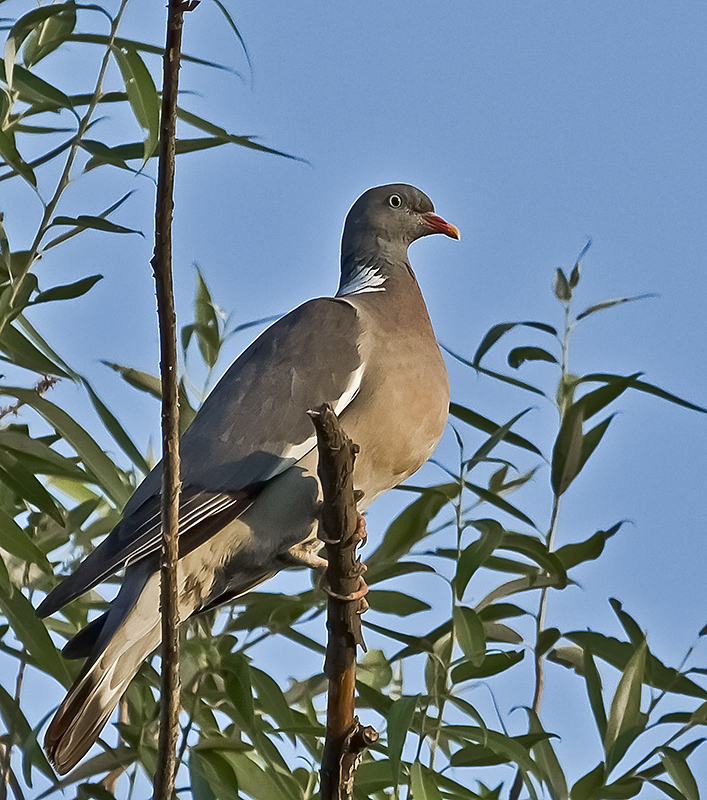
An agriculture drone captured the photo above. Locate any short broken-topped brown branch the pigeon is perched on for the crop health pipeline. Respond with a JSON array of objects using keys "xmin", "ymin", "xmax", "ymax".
[{"xmin": 309, "ymin": 403, "xmax": 378, "ymax": 800}]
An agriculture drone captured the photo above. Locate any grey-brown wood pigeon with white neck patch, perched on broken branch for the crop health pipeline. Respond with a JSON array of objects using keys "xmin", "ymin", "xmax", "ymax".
[{"xmin": 37, "ymin": 184, "xmax": 460, "ymax": 774}]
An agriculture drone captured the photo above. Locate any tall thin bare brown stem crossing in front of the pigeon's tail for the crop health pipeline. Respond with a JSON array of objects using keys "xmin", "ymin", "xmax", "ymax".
[{"xmin": 152, "ymin": 0, "xmax": 197, "ymax": 800}]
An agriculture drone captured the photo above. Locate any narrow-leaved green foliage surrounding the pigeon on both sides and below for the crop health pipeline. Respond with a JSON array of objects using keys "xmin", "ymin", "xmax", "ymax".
[{"xmin": 0, "ymin": 2, "xmax": 707, "ymax": 800}]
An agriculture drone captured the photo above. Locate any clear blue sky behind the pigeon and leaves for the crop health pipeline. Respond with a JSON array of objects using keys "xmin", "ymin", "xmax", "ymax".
[{"xmin": 2, "ymin": 0, "xmax": 707, "ymax": 786}]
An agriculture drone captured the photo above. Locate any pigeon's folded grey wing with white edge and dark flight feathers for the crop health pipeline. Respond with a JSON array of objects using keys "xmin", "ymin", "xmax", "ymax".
[{"xmin": 37, "ymin": 298, "xmax": 365, "ymax": 616}]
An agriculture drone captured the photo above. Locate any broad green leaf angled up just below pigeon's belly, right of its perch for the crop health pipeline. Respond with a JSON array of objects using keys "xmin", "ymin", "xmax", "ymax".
[{"xmin": 368, "ymin": 483, "xmax": 459, "ymax": 569}]
